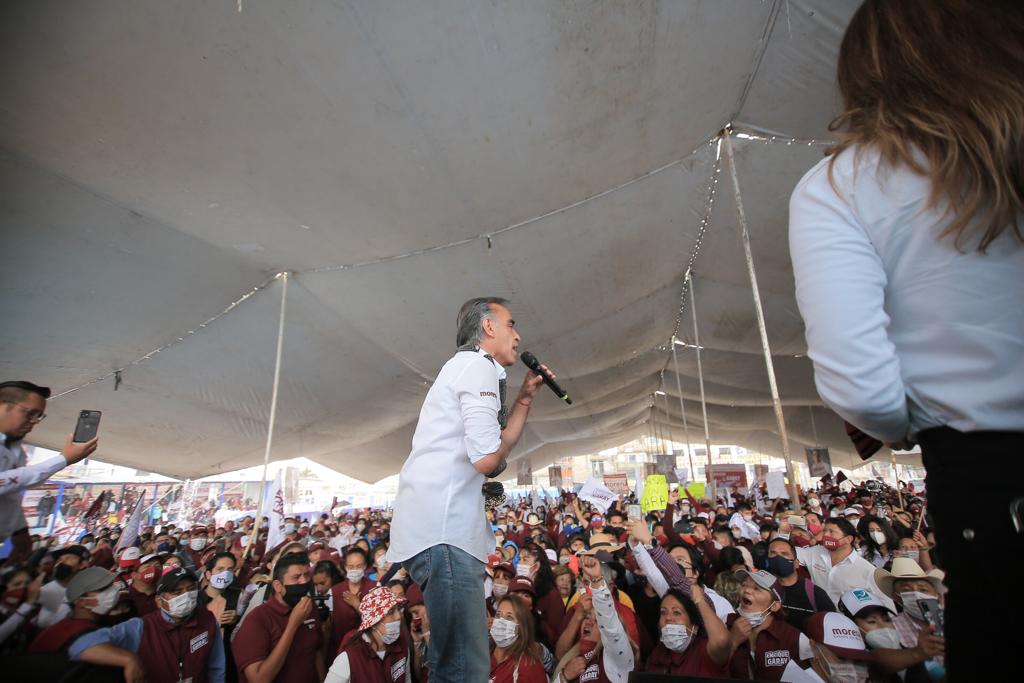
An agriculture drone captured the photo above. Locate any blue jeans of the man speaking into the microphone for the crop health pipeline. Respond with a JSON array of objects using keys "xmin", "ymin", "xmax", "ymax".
[{"xmin": 403, "ymin": 544, "xmax": 490, "ymax": 683}]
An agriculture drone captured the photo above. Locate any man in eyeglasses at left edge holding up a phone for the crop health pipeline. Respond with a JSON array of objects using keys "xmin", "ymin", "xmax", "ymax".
[{"xmin": 0, "ymin": 382, "xmax": 99, "ymax": 561}]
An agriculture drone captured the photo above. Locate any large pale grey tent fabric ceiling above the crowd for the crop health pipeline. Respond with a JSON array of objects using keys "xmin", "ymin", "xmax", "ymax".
[{"xmin": 0, "ymin": 0, "xmax": 917, "ymax": 481}]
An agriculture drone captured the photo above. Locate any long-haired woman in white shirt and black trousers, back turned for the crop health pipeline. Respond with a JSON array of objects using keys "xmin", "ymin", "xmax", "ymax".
[{"xmin": 790, "ymin": 0, "xmax": 1024, "ymax": 680}]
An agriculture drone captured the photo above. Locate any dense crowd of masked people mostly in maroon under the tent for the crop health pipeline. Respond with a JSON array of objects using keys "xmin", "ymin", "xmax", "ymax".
[{"xmin": 0, "ymin": 480, "xmax": 944, "ymax": 683}]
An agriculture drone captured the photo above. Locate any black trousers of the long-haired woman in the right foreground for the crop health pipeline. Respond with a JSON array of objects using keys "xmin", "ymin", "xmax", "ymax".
[{"xmin": 918, "ymin": 427, "xmax": 1024, "ymax": 682}]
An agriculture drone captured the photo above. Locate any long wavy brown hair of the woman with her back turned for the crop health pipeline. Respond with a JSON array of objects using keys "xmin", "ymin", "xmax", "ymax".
[{"xmin": 828, "ymin": 0, "xmax": 1024, "ymax": 253}]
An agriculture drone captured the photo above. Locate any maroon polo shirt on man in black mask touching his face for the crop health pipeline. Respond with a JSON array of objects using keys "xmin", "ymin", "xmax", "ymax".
[{"xmin": 231, "ymin": 596, "xmax": 323, "ymax": 683}]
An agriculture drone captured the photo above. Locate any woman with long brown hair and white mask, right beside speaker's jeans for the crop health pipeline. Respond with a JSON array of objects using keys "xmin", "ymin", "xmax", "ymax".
[{"xmin": 490, "ymin": 595, "xmax": 548, "ymax": 683}]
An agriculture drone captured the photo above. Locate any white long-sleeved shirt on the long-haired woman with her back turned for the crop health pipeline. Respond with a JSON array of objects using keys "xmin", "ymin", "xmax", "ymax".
[{"xmin": 790, "ymin": 148, "xmax": 1024, "ymax": 441}]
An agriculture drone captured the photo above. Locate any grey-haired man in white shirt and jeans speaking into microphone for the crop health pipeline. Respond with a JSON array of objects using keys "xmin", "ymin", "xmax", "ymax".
[{"xmin": 387, "ymin": 297, "xmax": 547, "ymax": 683}]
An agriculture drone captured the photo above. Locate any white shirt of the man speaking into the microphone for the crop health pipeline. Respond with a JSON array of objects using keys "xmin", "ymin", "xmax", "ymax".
[{"xmin": 387, "ymin": 350, "xmax": 505, "ymax": 562}]
